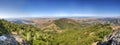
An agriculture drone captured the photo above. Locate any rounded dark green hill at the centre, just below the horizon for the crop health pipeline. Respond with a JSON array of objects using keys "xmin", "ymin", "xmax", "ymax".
[{"xmin": 54, "ymin": 18, "xmax": 80, "ymax": 29}]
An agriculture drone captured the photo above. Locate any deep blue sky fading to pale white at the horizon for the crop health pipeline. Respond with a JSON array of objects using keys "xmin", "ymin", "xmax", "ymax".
[{"xmin": 0, "ymin": 0, "xmax": 120, "ymax": 18}]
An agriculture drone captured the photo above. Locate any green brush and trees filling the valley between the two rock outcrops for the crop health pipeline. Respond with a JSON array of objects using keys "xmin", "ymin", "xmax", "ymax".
[{"xmin": 0, "ymin": 20, "xmax": 112, "ymax": 45}]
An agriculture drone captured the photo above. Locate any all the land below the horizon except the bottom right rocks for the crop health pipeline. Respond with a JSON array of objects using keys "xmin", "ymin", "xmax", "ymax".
[{"xmin": 0, "ymin": 18, "xmax": 120, "ymax": 45}]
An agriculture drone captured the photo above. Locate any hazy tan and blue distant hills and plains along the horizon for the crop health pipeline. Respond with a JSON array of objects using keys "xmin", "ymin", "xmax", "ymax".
[{"xmin": 6, "ymin": 17, "xmax": 120, "ymax": 27}]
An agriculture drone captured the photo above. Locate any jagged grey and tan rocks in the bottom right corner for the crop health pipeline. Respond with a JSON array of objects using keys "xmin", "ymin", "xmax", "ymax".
[{"xmin": 97, "ymin": 30, "xmax": 120, "ymax": 45}]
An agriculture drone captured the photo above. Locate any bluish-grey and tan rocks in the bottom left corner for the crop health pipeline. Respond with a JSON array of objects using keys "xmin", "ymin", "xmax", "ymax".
[{"xmin": 0, "ymin": 34, "xmax": 28, "ymax": 45}]
